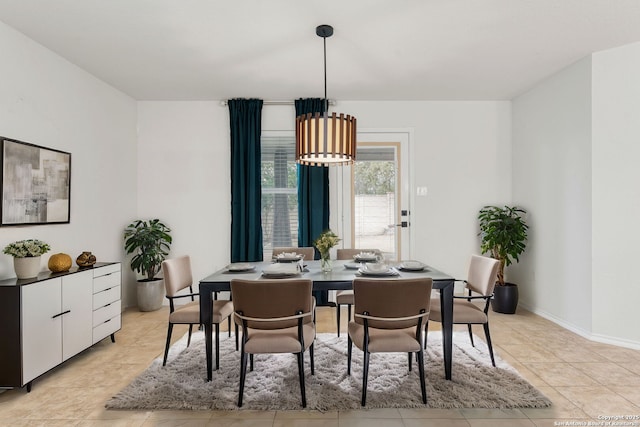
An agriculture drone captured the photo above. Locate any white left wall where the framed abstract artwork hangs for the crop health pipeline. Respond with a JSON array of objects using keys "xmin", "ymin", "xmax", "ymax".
[{"xmin": 0, "ymin": 23, "xmax": 137, "ymax": 304}]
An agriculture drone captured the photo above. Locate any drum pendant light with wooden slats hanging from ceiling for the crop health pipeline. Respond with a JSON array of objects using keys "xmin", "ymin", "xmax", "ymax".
[{"xmin": 296, "ymin": 25, "xmax": 356, "ymax": 166}]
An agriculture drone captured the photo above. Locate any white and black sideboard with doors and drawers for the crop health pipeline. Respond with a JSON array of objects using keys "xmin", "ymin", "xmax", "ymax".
[{"xmin": 0, "ymin": 263, "xmax": 122, "ymax": 391}]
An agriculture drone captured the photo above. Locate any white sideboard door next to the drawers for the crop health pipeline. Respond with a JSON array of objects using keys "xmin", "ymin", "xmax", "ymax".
[{"xmin": 62, "ymin": 270, "xmax": 93, "ymax": 361}]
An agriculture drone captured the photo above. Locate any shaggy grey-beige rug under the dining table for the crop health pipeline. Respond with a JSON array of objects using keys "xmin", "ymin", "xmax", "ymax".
[{"xmin": 106, "ymin": 332, "xmax": 551, "ymax": 411}]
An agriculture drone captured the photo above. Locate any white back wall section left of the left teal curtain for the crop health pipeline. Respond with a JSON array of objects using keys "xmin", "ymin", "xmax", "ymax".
[{"xmin": 137, "ymin": 101, "xmax": 231, "ymax": 286}]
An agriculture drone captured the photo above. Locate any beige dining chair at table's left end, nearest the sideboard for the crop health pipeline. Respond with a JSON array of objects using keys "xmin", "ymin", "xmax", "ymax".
[{"xmin": 162, "ymin": 255, "xmax": 237, "ymax": 369}]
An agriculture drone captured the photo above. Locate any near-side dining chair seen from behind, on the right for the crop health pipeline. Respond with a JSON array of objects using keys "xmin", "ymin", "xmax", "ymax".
[{"xmin": 347, "ymin": 277, "xmax": 433, "ymax": 406}]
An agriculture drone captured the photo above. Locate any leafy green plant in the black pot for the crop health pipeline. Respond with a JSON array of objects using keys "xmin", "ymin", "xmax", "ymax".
[{"xmin": 478, "ymin": 206, "xmax": 529, "ymax": 314}]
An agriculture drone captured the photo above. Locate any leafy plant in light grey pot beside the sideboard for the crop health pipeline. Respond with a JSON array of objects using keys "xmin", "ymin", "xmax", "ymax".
[{"xmin": 124, "ymin": 219, "xmax": 172, "ymax": 311}]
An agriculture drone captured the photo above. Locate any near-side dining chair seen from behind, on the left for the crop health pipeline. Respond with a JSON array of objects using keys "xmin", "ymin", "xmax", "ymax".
[{"xmin": 231, "ymin": 279, "xmax": 316, "ymax": 408}]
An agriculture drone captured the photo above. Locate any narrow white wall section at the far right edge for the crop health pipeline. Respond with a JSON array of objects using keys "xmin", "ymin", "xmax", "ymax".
[{"xmin": 592, "ymin": 43, "xmax": 640, "ymax": 348}]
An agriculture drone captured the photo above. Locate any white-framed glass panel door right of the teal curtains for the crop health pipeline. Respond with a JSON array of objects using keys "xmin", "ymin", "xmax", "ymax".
[{"xmin": 329, "ymin": 129, "xmax": 413, "ymax": 261}]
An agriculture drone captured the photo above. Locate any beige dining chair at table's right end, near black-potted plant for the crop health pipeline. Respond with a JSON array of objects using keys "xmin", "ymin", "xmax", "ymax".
[{"xmin": 425, "ymin": 255, "xmax": 500, "ymax": 366}]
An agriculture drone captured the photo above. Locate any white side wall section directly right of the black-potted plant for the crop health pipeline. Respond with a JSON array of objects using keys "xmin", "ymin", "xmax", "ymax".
[{"xmin": 507, "ymin": 58, "xmax": 592, "ymax": 335}]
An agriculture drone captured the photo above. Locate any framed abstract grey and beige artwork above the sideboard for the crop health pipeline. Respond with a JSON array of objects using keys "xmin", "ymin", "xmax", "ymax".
[{"xmin": 0, "ymin": 137, "xmax": 71, "ymax": 226}]
